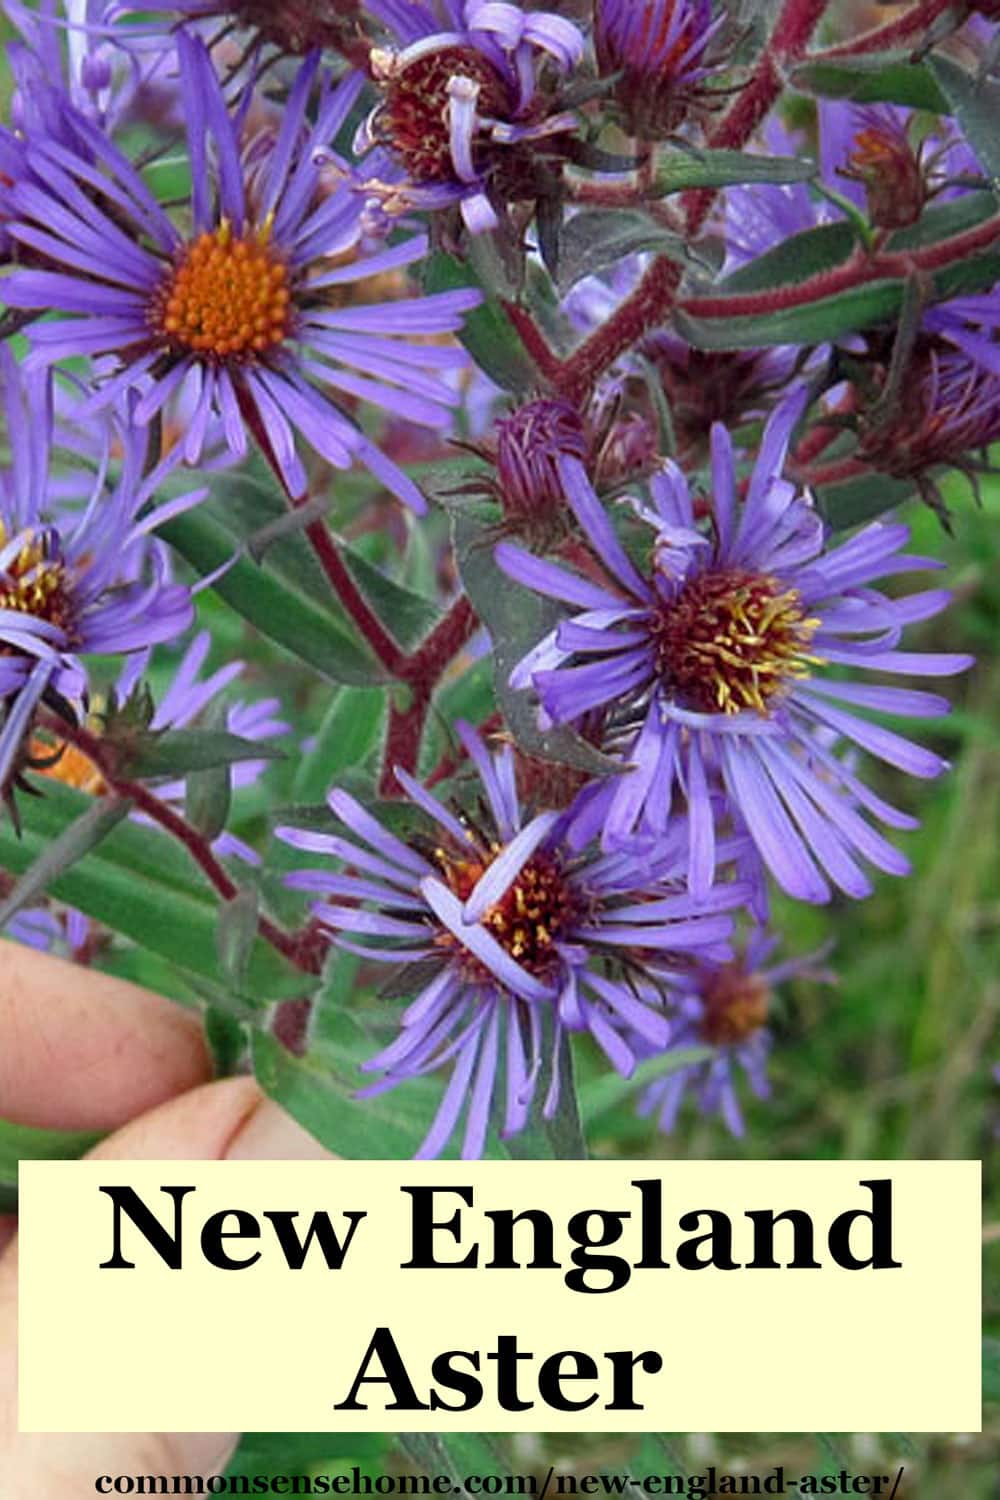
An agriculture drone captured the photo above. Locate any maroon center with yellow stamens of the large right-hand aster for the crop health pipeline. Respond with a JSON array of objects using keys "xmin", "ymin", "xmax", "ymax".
[{"xmin": 652, "ymin": 569, "xmax": 822, "ymax": 714}]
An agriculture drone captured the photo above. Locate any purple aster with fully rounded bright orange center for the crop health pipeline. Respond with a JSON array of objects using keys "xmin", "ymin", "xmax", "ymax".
[{"xmin": 4, "ymin": 30, "xmax": 478, "ymax": 510}]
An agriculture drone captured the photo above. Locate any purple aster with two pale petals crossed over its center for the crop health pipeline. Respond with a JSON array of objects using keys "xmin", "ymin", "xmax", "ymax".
[{"xmin": 279, "ymin": 725, "xmax": 745, "ymax": 1157}]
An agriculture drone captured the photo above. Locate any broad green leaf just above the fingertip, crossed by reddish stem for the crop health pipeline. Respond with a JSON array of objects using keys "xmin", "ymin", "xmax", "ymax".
[{"xmin": 0, "ymin": 782, "xmax": 301, "ymax": 1004}]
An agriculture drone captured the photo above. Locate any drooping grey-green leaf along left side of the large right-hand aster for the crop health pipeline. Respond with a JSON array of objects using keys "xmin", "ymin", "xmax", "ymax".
[{"xmin": 453, "ymin": 513, "xmax": 622, "ymax": 776}]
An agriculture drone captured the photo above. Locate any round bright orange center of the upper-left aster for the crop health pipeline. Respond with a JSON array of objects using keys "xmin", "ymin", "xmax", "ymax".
[{"xmin": 150, "ymin": 219, "xmax": 292, "ymax": 362}]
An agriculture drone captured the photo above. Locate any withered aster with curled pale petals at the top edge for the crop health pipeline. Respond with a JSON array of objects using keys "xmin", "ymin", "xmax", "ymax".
[{"xmin": 357, "ymin": 0, "xmax": 583, "ymax": 234}]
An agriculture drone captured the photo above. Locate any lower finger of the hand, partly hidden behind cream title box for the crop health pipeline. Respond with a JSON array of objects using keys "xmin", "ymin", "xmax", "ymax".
[{"xmin": 0, "ymin": 1079, "xmax": 327, "ymax": 1500}]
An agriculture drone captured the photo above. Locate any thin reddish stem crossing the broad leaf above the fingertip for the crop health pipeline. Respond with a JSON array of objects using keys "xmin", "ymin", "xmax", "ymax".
[{"xmin": 40, "ymin": 716, "xmax": 327, "ymax": 974}]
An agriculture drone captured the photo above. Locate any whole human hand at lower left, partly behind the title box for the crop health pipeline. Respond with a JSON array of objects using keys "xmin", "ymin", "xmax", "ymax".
[{"xmin": 0, "ymin": 942, "xmax": 325, "ymax": 1500}]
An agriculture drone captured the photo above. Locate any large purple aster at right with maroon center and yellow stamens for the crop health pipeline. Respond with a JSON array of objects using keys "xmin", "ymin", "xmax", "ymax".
[{"xmin": 496, "ymin": 392, "xmax": 970, "ymax": 902}]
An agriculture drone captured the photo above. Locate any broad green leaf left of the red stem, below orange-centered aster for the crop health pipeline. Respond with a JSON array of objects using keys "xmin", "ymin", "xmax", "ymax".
[{"xmin": 160, "ymin": 506, "xmax": 382, "ymax": 686}]
